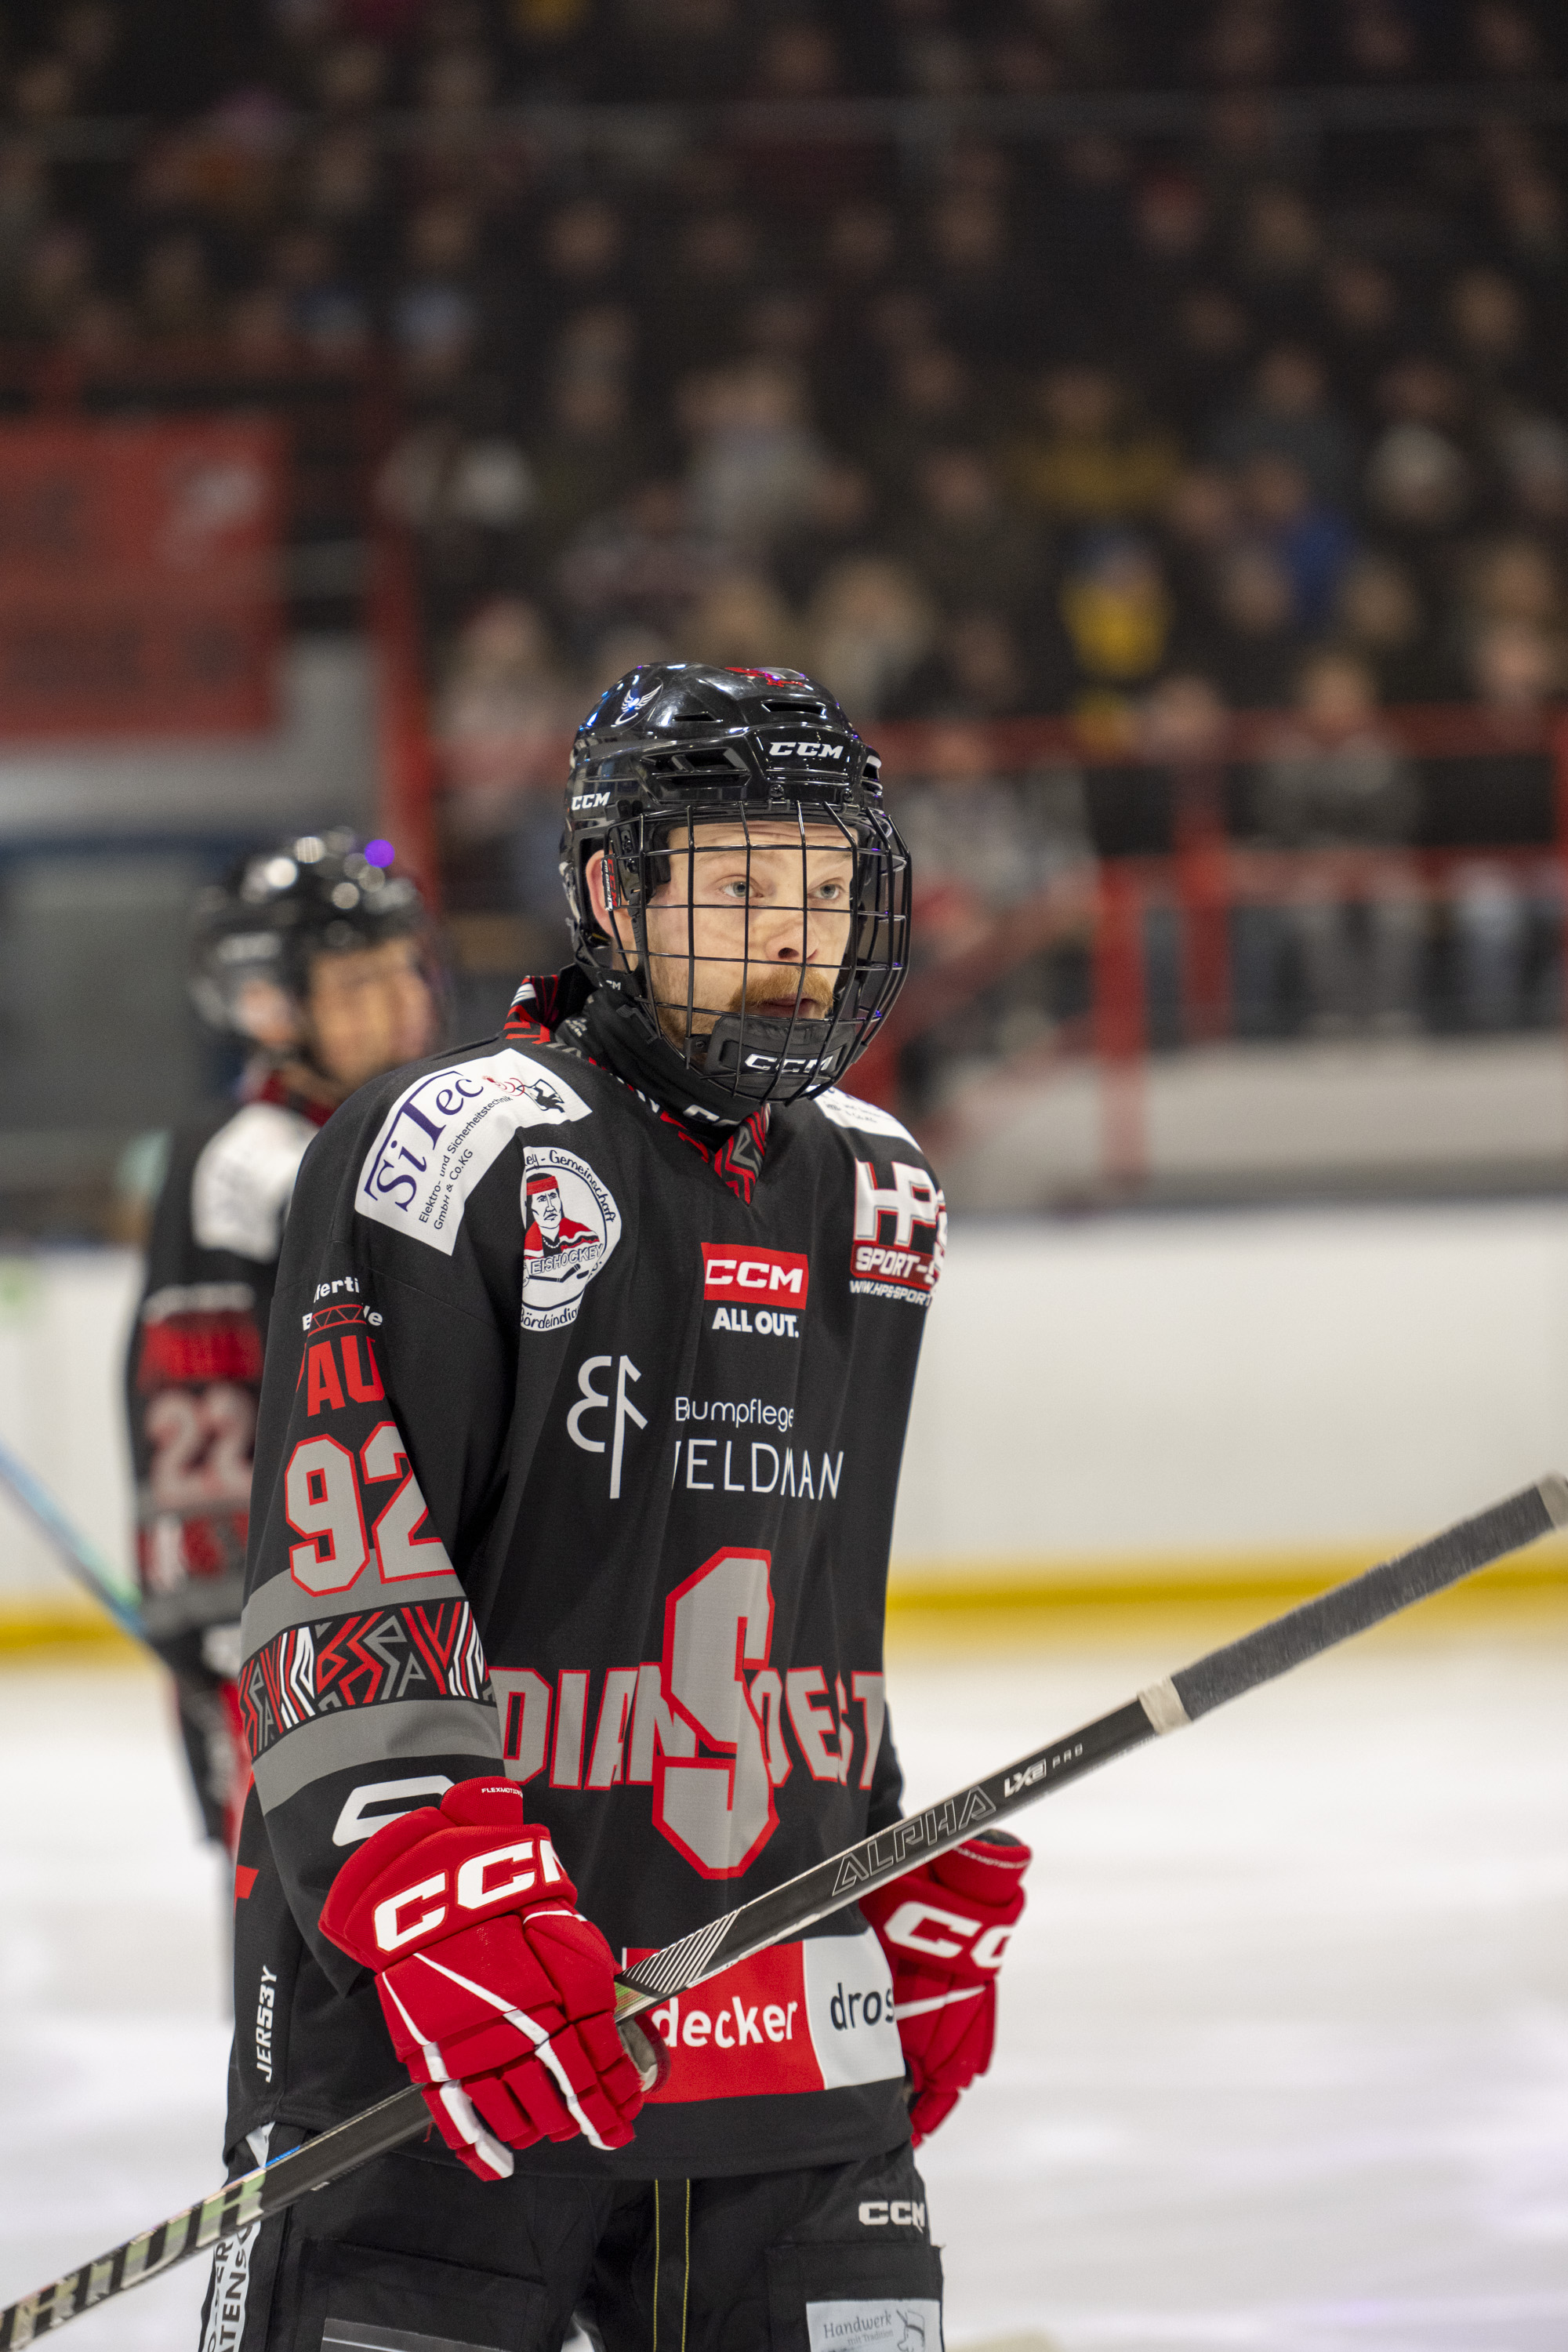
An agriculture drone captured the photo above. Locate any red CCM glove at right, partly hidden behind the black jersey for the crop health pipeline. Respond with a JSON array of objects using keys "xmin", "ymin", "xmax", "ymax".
[{"xmin": 860, "ymin": 1830, "xmax": 1029, "ymax": 2147}]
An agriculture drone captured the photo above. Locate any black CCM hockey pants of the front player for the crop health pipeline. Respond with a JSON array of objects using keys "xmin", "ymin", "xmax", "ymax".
[{"xmin": 202, "ymin": 2131, "xmax": 942, "ymax": 2352}]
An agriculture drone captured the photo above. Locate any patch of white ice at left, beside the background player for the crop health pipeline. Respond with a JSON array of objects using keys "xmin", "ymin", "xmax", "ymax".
[{"xmin": 0, "ymin": 1668, "xmax": 228, "ymax": 2352}]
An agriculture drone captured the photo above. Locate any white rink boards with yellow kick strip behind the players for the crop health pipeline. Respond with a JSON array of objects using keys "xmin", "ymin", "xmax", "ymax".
[{"xmin": 15, "ymin": 1202, "xmax": 1568, "ymax": 1635}]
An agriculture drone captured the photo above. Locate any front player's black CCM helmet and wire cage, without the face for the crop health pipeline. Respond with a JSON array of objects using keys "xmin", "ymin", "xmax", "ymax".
[{"xmin": 562, "ymin": 661, "xmax": 909, "ymax": 1105}]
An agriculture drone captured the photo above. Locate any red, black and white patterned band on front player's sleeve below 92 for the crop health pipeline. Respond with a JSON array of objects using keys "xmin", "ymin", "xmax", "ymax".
[{"xmin": 240, "ymin": 1599, "xmax": 492, "ymax": 1762}]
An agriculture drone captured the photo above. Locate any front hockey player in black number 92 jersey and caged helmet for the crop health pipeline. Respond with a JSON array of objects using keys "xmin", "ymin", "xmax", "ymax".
[{"xmin": 205, "ymin": 663, "xmax": 1027, "ymax": 2352}]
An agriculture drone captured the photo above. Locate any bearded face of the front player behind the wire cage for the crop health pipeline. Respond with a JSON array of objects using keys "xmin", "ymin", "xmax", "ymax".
[{"xmin": 590, "ymin": 818, "xmax": 853, "ymax": 1044}]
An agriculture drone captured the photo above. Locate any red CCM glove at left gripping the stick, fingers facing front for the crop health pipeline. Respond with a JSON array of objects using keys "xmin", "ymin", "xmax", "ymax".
[{"xmin": 322, "ymin": 1780, "xmax": 644, "ymax": 2180}]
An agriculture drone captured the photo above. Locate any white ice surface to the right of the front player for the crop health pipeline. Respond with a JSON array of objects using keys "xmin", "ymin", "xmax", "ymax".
[{"xmin": 893, "ymin": 1618, "xmax": 1568, "ymax": 2352}]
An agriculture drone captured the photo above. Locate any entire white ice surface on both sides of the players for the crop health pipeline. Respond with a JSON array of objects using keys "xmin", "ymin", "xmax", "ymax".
[{"xmin": 0, "ymin": 1618, "xmax": 1568, "ymax": 2352}]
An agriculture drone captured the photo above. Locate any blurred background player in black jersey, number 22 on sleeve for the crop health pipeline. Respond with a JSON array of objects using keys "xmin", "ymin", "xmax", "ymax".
[{"xmin": 125, "ymin": 833, "xmax": 435, "ymax": 1849}]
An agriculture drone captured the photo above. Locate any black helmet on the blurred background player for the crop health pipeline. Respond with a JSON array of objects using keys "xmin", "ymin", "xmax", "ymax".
[{"xmin": 191, "ymin": 828, "xmax": 428, "ymax": 1037}]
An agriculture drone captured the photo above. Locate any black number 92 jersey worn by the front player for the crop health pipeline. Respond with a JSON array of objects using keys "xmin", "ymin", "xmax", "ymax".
[{"xmin": 230, "ymin": 1002, "xmax": 945, "ymax": 2178}]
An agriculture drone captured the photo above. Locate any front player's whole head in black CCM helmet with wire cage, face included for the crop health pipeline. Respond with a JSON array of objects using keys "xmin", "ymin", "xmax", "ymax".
[{"xmin": 562, "ymin": 663, "xmax": 909, "ymax": 1117}]
